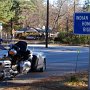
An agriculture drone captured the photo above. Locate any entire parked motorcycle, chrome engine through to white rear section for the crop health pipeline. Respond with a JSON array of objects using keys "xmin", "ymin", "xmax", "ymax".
[{"xmin": 0, "ymin": 41, "xmax": 46, "ymax": 79}]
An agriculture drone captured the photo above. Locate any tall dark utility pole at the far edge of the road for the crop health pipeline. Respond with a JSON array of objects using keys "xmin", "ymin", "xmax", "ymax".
[{"xmin": 46, "ymin": 0, "xmax": 49, "ymax": 48}]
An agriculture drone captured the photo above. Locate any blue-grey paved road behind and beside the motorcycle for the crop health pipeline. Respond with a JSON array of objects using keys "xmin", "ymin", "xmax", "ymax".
[{"xmin": 0, "ymin": 44, "xmax": 89, "ymax": 86}]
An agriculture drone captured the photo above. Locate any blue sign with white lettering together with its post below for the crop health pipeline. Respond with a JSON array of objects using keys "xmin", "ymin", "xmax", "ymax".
[{"xmin": 74, "ymin": 12, "xmax": 90, "ymax": 90}]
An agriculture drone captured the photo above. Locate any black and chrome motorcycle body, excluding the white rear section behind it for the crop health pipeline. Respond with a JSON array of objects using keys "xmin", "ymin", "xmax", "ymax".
[{"xmin": 0, "ymin": 41, "xmax": 32, "ymax": 79}]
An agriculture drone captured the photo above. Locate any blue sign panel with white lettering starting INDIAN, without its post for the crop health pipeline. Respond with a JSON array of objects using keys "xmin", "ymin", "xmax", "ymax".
[{"xmin": 74, "ymin": 13, "xmax": 90, "ymax": 34}]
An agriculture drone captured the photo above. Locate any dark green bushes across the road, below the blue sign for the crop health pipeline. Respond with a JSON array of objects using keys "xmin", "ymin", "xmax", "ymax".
[{"xmin": 54, "ymin": 32, "xmax": 89, "ymax": 45}]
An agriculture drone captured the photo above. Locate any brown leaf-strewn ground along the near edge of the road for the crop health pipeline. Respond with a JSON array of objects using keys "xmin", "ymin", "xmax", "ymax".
[{"xmin": 0, "ymin": 72, "xmax": 88, "ymax": 90}]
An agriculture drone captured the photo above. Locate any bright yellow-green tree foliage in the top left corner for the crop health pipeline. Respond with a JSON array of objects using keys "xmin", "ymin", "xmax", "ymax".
[{"xmin": 0, "ymin": 0, "xmax": 15, "ymax": 23}]
